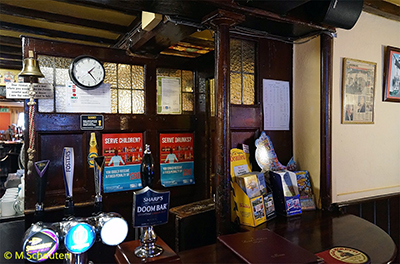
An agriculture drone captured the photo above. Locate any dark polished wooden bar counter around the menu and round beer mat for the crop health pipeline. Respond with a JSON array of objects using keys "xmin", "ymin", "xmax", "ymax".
[{"xmin": 179, "ymin": 211, "xmax": 397, "ymax": 263}]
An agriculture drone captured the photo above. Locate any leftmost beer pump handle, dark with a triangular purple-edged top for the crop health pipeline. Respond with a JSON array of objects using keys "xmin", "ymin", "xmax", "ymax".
[{"xmin": 34, "ymin": 160, "xmax": 50, "ymax": 222}]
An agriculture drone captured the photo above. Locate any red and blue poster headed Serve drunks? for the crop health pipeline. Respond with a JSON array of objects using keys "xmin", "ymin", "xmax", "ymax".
[{"xmin": 160, "ymin": 133, "xmax": 195, "ymax": 187}]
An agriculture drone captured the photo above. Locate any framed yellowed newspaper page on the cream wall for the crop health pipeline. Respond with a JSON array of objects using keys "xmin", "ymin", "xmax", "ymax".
[{"xmin": 342, "ymin": 58, "xmax": 376, "ymax": 124}]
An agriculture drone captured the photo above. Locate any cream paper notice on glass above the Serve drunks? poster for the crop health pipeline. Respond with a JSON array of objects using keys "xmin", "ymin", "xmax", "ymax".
[{"xmin": 157, "ymin": 77, "xmax": 181, "ymax": 114}]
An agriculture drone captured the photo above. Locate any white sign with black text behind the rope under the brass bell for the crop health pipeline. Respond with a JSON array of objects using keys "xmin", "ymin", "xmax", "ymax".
[{"xmin": 6, "ymin": 83, "xmax": 54, "ymax": 99}]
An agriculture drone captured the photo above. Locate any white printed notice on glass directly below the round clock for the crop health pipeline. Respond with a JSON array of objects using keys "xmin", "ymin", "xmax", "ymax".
[{"xmin": 65, "ymin": 82, "xmax": 111, "ymax": 113}]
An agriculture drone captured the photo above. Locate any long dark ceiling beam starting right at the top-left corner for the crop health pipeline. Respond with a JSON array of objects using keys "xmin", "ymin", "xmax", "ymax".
[{"xmin": 0, "ymin": 3, "xmax": 128, "ymax": 34}]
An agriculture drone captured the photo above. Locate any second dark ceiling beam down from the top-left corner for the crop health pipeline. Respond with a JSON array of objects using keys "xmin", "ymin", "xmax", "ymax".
[{"xmin": 0, "ymin": 22, "xmax": 116, "ymax": 45}]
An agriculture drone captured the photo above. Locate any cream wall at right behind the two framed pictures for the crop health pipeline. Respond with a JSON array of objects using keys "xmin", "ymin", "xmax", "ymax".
[{"xmin": 332, "ymin": 12, "xmax": 400, "ymax": 202}]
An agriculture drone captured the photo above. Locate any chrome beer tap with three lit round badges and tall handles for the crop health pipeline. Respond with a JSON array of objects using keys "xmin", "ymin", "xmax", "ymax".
[{"xmin": 23, "ymin": 147, "xmax": 128, "ymax": 264}]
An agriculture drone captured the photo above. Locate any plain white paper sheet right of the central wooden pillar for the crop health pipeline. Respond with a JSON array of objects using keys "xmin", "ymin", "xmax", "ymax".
[{"xmin": 263, "ymin": 79, "xmax": 290, "ymax": 130}]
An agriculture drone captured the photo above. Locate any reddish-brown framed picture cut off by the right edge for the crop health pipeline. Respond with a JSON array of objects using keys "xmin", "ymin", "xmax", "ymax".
[{"xmin": 383, "ymin": 46, "xmax": 400, "ymax": 102}]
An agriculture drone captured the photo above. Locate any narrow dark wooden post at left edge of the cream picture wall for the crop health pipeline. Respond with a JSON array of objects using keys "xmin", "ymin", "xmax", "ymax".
[{"xmin": 320, "ymin": 34, "xmax": 333, "ymax": 209}]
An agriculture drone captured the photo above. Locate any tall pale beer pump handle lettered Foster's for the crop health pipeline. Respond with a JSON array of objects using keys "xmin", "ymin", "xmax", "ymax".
[{"xmin": 63, "ymin": 147, "xmax": 74, "ymax": 217}]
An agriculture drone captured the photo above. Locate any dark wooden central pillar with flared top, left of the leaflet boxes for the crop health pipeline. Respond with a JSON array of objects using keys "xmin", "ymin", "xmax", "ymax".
[{"xmin": 203, "ymin": 10, "xmax": 244, "ymax": 235}]
